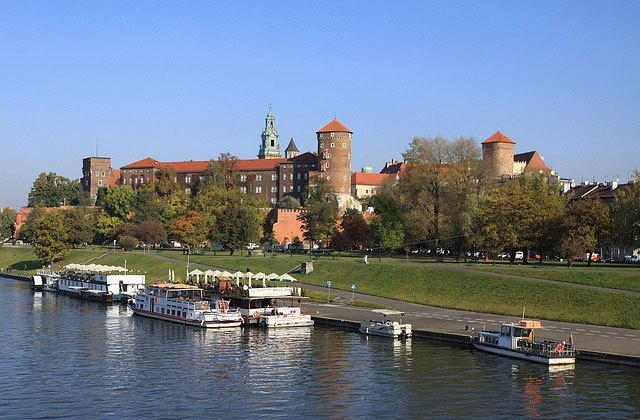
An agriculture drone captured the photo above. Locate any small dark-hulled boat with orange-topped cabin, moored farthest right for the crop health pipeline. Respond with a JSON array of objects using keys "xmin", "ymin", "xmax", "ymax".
[{"xmin": 473, "ymin": 318, "xmax": 576, "ymax": 365}]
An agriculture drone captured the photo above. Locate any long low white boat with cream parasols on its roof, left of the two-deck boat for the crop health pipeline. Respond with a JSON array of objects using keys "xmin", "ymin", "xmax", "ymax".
[{"xmin": 58, "ymin": 264, "xmax": 145, "ymax": 303}]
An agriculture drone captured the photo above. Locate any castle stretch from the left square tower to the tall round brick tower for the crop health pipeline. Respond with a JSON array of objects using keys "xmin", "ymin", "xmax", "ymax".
[{"xmin": 81, "ymin": 109, "xmax": 360, "ymax": 210}]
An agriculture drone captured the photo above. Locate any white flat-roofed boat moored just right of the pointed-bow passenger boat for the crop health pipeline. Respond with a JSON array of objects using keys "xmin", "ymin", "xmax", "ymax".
[{"xmin": 206, "ymin": 277, "xmax": 314, "ymax": 328}]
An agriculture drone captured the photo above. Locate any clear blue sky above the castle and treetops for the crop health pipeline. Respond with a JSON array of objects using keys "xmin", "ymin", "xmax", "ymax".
[{"xmin": 0, "ymin": 0, "xmax": 640, "ymax": 207}]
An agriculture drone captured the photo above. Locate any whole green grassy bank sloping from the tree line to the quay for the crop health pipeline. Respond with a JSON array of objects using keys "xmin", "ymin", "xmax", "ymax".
[{"xmin": 0, "ymin": 248, "xmax": 640, "ymax": 329}]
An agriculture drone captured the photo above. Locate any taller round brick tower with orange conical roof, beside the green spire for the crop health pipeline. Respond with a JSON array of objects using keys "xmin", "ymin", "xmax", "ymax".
[{"xmin": 316, "ymin": 119, "xmax": 353, "ymax": 196}]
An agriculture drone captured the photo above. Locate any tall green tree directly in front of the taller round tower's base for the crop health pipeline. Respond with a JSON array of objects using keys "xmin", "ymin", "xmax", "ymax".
[{"xmin": 298, "ymin": 177, "xmax": 338, "ymax": 246}]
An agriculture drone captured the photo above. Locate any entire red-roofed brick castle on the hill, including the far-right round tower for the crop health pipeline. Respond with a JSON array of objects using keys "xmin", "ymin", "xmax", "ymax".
[{"xmin": 81, "ymin": 107, "xmax": 557, "ymax": 210}]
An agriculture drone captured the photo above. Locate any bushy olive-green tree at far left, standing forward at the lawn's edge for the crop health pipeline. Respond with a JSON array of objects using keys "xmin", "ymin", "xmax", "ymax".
[{"xmin": 36, "ymin": 210, "xmax": 68, "ymax": 265}]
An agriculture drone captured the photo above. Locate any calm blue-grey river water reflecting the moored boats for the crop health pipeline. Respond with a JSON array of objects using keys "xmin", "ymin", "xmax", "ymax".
[{"xmin": 0, "ymin": 279, "xmax": 640, "ymax": 419}]
